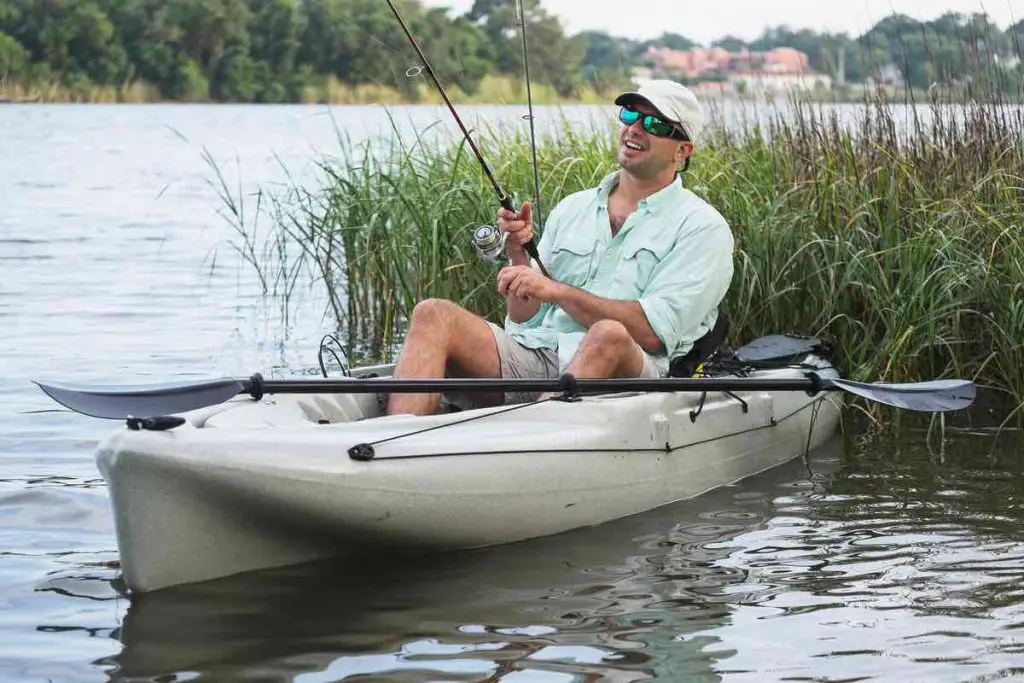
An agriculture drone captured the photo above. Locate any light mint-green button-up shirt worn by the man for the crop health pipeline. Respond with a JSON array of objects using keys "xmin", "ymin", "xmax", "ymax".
[{"xmin": 505, "ymin": 171, "xmax": 733, "ymax": 375}]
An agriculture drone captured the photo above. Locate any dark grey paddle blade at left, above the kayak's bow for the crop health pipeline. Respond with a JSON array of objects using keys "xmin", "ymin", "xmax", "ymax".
[{"xmin": 36, "ymin": 378, "xmax": 248, "ymax": 420}]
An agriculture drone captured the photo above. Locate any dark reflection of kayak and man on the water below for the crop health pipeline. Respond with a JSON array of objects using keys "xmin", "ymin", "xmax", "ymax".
[{"xmin": 109, "ymin": 438, "xmax": 842, "ymax": 681}]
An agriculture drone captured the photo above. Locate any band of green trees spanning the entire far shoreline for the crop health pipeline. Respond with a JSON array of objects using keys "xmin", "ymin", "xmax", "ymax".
[{"xmin": 0, "ymin": 0, "xmax": 1024, "ymax": 102}]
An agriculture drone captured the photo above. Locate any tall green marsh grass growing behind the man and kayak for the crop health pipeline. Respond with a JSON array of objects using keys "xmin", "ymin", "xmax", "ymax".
[{"xmin": 225, "ymin": 95, "xmax": 1024, "ymax": 417}]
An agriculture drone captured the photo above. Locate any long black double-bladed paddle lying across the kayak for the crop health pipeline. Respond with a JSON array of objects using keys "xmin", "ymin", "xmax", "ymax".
[{"xmin": 36, "ymin": 373, "xmax": 975, "ymax": 419}]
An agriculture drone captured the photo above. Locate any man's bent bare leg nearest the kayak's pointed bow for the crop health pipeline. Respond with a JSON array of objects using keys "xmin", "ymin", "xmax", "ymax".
[{"xmin": 387, "ymin": 299, "xmax": 501, "ymax": 415}]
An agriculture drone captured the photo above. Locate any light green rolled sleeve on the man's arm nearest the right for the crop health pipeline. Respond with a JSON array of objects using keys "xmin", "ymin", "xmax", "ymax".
[{"xmin": 639, "ymin": 223, "xmax": 733, "ymax": 358}]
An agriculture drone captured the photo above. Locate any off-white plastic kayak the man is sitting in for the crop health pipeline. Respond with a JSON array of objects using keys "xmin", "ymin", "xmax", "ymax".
[{"xmin": 97, "ymin": 335, "xmax": 839, "ymax": 591}]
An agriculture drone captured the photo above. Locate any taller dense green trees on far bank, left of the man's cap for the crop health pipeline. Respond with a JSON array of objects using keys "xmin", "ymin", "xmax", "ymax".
[{"xmin": 0, "ymin": 0, "xmax": 629, "ymax": 102}]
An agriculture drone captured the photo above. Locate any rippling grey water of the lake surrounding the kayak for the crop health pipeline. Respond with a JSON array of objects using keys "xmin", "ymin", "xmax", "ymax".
[{"xmin": 0, "ymin": 105, "xmax": 1024, "ymax": 683}]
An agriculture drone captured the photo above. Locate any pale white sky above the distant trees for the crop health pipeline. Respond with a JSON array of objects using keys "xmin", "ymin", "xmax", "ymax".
[{"xmin": 423, "ymin": 0, "xmax": 1024, "ymax": 44}]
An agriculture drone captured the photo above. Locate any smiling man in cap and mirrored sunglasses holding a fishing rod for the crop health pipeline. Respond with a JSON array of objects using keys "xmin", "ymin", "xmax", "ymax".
[{"xmin": 388, "ymin": 81, "xmax": 733, "ymax": 415}]
